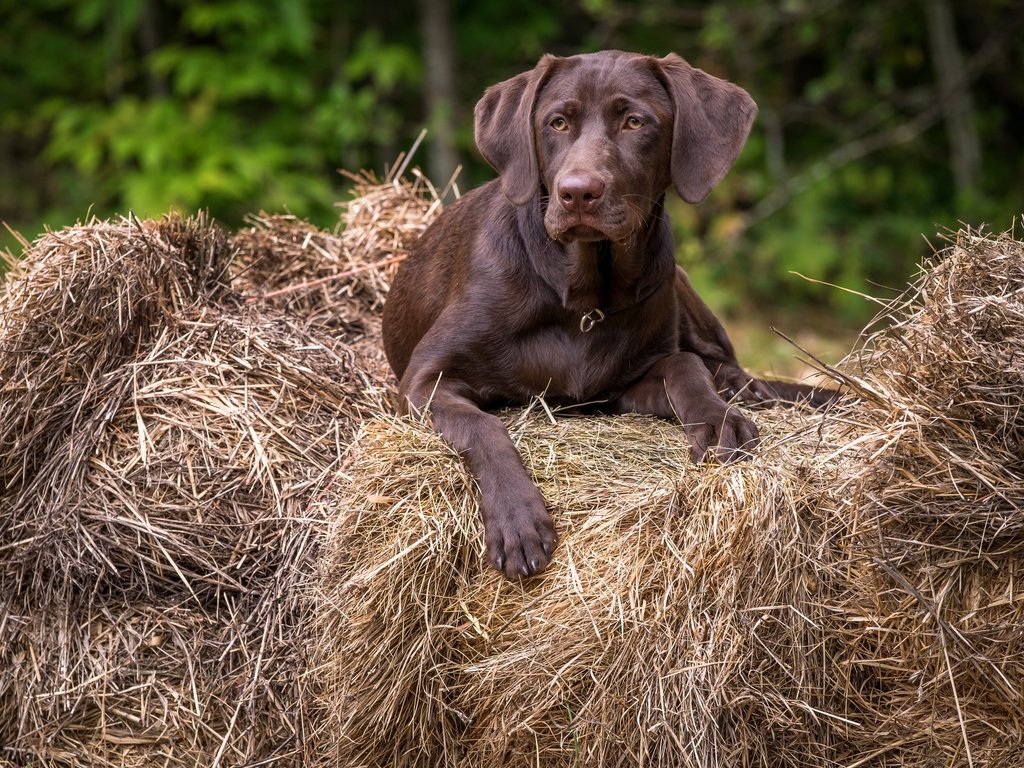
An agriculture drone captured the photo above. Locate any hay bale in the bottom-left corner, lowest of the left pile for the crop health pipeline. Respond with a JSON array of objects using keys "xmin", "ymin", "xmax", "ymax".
[{"xmin": 0, "ymin": 594, "xmax": 309, "ymax": 768}]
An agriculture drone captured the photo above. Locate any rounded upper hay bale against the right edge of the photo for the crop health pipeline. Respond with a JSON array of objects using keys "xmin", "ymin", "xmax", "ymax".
[{"xmin": 850, "ymin": 231, "xmax": 1024, "ymax": 556}]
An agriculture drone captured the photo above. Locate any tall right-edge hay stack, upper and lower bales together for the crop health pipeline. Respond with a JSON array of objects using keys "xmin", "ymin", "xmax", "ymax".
[{"xmin": 820, "ymin": 231, "xmax": 1024, "ymax": 766}]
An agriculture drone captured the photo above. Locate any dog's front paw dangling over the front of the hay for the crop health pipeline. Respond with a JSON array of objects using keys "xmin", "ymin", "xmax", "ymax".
[{"xmin": 483, "ymin": 485, "xmax": 558, "ymax": 580}]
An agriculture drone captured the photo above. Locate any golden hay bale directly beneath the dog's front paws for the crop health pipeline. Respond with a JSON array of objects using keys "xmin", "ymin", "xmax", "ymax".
[{"xmin": 317, "ymin": 405, "xmax": 847, "ymax": 766}]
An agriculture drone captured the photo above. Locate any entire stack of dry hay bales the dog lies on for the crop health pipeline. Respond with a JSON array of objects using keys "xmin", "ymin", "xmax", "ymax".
[{"xmin": 0, "ymin": 162, "xmax": 1024, "ymax": 768}]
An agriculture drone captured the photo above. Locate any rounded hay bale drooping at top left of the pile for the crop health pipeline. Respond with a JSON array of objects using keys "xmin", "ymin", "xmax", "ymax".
[{"xmin": 0, "ymin": 216, "xmax": 229, "ymax": 499}]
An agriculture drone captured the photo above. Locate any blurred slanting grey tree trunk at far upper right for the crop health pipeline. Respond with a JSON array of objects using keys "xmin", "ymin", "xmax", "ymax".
[{"xmin": 925, "ymin": 0, "xmax": 981, "ymax": 195}]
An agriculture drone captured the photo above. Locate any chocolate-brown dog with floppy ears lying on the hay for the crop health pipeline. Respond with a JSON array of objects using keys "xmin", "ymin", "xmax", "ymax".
[{"xmin": 384, "ymin": 51, "xmax": 828, "ymax": 578}]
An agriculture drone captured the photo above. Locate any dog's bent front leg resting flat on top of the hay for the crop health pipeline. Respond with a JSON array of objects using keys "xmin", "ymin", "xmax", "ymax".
[{"xmin": 612, "ymin": 352, "xmax": 758, "ymax": 462}]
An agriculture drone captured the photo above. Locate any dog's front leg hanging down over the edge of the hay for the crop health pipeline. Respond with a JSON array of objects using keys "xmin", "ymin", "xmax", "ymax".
[{"xmin": 401, "ymin": 376, "xmax": 558, "ymax": 579}]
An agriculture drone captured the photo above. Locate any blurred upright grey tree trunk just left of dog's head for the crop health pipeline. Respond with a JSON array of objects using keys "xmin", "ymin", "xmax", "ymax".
[{"xmin": 419, "ymin": 0, "xmax": 459, "ymax": 186}]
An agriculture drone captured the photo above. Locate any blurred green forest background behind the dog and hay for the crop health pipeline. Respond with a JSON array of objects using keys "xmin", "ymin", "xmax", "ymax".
[{"xmin": 0, "ymin": 0, "xmax": 1024, "ymax": 368}]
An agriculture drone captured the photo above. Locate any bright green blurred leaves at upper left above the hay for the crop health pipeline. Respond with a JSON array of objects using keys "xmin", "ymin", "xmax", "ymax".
[{"xmin": 2, "ymin": 0, "xmax": 420, "ymax": 240}]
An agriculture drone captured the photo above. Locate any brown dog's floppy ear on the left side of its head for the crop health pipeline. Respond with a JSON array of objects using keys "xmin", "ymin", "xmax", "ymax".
[{"xmin": 473, "ymin": 55, "xmax": 556, "ymax": 206}]
